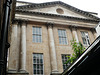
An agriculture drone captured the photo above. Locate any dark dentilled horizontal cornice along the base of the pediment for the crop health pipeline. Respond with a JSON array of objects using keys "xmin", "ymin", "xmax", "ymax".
[{"xmin": 16, "ymin": 10, "xmax": 100, "ymax": 22}]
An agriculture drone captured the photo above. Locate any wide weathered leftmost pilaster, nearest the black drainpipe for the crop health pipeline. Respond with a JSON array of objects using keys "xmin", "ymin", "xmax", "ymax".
[{"xmin": 8, "ymin": 23, "xmax": 19, "ymax": 70}]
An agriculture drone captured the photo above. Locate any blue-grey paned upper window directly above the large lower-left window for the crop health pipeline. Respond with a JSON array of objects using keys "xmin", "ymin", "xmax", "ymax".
[{"xmin": 33, "ymin": 26, "xmax": 42, "ymax": 43}]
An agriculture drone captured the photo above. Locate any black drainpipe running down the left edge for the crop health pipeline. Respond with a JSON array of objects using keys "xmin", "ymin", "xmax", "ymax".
[{"xmin": 0, "ymin": 0, "xmax": 12, "ymax": 75}]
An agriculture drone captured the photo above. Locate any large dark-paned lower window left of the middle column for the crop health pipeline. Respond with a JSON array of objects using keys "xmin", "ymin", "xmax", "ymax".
[{"xmin": 33, "ymin": 54, "xmax": 44, "ymax": 75}]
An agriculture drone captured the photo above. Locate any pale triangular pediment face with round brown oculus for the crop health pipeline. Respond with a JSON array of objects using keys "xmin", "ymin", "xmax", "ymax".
[{"xmin": 28, "ymin": 5, "xmax": 87, "ymax": 18}]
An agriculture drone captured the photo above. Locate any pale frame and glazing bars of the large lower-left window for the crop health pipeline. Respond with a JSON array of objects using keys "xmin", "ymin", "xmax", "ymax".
[{"xmin": 33, "ymin": 53, "xmax": 44, "ymax": 75}]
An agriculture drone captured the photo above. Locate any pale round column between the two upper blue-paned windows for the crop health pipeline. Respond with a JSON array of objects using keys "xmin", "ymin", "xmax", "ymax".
[{"xmin": 48, "ymin": 24, "xmax": 58, "ymax": 73}]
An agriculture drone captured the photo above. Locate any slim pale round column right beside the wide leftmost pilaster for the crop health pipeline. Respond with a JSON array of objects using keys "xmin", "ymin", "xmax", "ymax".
[{"xmin": 21, "ymin": 22, "xmax": 26, "ymax": 70}]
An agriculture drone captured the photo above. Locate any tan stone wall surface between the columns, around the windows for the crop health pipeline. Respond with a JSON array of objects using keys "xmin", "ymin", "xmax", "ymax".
[{"xmin": 26, "ymin": 23, "xmax": 95, "ymax": 75}]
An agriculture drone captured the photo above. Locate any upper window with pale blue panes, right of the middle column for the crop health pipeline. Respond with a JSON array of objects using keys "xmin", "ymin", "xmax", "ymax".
[{"xmin": 58, "ymin": 29, "xmax": 68, "ymax": 45}]
